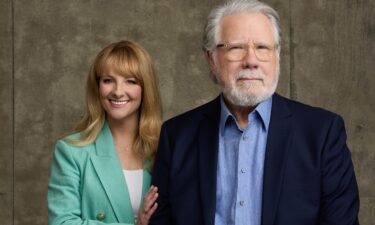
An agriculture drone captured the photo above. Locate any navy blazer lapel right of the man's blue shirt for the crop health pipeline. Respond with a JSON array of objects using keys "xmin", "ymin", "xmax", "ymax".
[{"xmin": 262, "ymin": 94, "xmax": 293, "ymax": 225}]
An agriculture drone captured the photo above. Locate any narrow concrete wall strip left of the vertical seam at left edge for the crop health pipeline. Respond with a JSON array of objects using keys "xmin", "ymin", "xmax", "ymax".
[{"xmin": 0, "ymin": 1, "xmax": 14, "ymax": 225}]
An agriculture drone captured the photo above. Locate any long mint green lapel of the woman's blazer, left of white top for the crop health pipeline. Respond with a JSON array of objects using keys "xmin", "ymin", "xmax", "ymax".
[{"xmin": 91, "ymin": 123, "xmax": 134, "ymax": 223}]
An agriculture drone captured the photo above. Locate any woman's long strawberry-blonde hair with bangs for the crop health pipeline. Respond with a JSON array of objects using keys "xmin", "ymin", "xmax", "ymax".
[{"xmin": 67, "ymin": 41, "xmax": 162, "ymax": 168}]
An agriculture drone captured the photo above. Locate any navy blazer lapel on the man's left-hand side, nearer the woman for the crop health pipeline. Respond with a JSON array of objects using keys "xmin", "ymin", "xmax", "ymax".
[{"xmin": 197, "ymin": 97, "xmax": 220, "ymax": 225}]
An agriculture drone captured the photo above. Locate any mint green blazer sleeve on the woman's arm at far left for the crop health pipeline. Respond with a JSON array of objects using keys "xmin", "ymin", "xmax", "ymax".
[{"xmin": 47, "ymin": 141, "xmax": 133, "ymax": 225}]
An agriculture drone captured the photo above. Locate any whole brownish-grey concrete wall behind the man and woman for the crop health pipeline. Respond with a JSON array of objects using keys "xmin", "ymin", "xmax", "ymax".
[{"xmin": 0, "ymin": 0, "xmax": 375, "ymax": 225}]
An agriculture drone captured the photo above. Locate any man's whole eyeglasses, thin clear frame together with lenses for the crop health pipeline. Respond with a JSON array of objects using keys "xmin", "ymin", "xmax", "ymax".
[{"xmin": 216, "ymin": 43, "xmax": 277, "ymax": 62}]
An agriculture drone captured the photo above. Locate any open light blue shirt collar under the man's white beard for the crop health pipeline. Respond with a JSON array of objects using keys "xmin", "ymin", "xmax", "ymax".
[{"xmin": 220, "ymin": 95, "xmax": 272, "ymax": 134}]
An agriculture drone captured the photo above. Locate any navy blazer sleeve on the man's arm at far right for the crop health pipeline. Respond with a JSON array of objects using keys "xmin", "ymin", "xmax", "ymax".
[{"xmin": 319, "ymin": 116, "xmax": 359, "ymax": 225}]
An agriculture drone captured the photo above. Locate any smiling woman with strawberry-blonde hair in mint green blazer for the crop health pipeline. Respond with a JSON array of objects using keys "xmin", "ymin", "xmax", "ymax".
[{"xmin": 48, "ymin": 41, "xmax": 161, "ymax": 225}]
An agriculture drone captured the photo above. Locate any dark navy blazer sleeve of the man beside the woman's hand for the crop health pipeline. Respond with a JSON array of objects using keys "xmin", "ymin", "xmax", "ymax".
[{"xmin": 149, "ymin": 125, "xmax": 172, "ymax": 225}]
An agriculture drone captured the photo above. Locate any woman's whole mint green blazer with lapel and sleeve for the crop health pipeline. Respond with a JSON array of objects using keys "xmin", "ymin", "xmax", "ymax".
[{"xmin": 47, "ymin": 123, "xmax": 151, "ymax": 225}]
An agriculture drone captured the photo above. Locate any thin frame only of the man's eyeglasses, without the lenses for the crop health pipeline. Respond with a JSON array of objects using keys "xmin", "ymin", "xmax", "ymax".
[{"xmin": 216, "ymin": 42, "xmax": 279, "ymax": 62}]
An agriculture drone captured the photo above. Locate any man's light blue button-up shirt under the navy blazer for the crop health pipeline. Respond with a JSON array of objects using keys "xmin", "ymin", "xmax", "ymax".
[{"xmin": 215, "ymin": 96, "xmax": 272, "ymax": 225}]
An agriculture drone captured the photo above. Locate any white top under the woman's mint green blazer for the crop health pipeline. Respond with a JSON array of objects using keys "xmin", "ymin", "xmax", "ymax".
[{"xmin": 123, "ymin": 169, "xmax": 143, "ymax": 222}]
